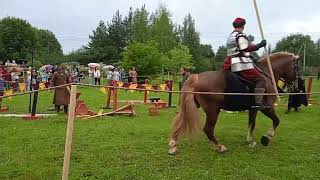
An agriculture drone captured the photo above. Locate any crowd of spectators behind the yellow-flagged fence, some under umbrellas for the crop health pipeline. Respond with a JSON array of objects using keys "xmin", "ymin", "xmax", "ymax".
[{"xmin": 0, "ymin": 61, "xmax": 138, "ymax": 91}]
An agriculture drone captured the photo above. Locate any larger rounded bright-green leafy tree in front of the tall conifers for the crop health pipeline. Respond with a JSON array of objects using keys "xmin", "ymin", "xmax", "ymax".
[{"xmin": 121, "ymin": 41, "xmax": 165, "ymax": 75}]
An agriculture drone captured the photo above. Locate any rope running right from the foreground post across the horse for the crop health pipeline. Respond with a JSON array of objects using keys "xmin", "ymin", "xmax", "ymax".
[{"xmin": 76, "ymin": 83, "xmax": 320, "ymax": 96}]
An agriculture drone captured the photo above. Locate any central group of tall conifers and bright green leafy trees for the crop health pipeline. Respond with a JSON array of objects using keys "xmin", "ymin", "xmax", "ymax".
[{"xmin": 67, "ymin": 6, "xmax": 215, "ymax": 74}]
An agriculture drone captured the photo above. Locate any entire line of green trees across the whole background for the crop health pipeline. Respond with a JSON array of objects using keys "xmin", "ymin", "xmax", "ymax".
[{"xmin": 0, "ymin": 5, "xmax": 320, "ymax": 75}]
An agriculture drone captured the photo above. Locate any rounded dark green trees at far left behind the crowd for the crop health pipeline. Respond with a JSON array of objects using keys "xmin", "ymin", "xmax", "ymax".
[{"xmin": 0, "ymin": 17, "xmax": 64, "ymax": 67}]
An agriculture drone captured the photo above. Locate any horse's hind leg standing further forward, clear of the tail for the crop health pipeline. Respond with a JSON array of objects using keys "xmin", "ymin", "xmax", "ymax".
[{"xmin": 203, "ymin": 107, "xmax": 227, "ymax": 152}]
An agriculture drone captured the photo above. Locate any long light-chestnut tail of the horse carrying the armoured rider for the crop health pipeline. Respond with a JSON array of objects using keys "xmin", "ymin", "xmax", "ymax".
[{"xmin": 171, "ymin": 74, "xmax": 199, "ymax": 139}]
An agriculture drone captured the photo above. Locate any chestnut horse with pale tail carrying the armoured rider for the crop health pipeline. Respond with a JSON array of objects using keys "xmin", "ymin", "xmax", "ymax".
[{"xmin": 169, "ymin": 52, "xmax": 299, "ymax": 154}]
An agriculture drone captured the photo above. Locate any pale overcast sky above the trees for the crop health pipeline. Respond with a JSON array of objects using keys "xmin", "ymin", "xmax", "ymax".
[{"xmin": 0, "ymin": 0, "xmax": 320, "ymax": 53}]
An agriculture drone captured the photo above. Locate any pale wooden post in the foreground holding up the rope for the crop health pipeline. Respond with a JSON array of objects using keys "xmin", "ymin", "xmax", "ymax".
[{"xmin": 62, "ymin": 85, "xmax": 77, "ymax": 180}]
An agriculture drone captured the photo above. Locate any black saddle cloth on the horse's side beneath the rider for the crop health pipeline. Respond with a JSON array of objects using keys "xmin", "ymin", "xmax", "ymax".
[{"xmin": 223, "ymin": 71, "xmax": 255, "ymax": 111}]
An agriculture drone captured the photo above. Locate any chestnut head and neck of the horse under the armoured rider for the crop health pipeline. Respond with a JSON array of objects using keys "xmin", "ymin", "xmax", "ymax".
[{"xmin": 261, "ymin": 52, "xmax": 300, "ymax": 82}]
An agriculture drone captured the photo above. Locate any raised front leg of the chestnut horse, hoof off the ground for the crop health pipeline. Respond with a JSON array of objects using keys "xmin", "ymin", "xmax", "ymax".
[{"xmin": 261, "ymin": 108, "xmax": 280, "ymax": 146}]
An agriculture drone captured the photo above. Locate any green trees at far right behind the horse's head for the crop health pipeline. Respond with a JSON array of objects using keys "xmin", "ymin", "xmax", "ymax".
[{"xmin": 274, "ymin": 33, "xmax": 320, "ymax": 66}]
